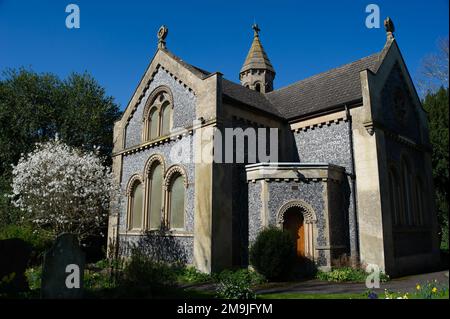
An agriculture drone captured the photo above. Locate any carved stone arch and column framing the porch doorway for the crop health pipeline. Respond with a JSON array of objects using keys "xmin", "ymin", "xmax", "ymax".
[{"xmin": 277, "ymin": 200, "xmax": 317, "ymax": 260}]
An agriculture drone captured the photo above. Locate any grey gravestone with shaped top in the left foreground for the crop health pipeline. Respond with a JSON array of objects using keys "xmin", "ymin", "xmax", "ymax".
[{"xmin": 41, "ymin": 234, "xmax": 85, "ymax": 299}]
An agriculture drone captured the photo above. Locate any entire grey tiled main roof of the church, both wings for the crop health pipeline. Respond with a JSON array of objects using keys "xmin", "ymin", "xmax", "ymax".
[{"xmin": 166, "ymin": 47, "xmax": 383, "ymax": 120}]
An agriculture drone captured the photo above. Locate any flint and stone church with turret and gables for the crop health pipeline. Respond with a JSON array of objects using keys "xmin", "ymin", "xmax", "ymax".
[{"xmin": 108, "ymin": 18, "xmax": 439, "ymax": 276}]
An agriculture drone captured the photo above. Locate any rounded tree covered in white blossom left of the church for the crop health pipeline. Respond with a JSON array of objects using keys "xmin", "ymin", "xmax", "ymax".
[{"xmin": 11, "ymin": 139, "xmax": 119, "ymax": 240}]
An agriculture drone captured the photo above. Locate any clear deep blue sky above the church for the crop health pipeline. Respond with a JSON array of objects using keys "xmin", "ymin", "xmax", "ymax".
[{"xmin": 0, "ymin": 0, "xmax": 449, "ymax": 109}]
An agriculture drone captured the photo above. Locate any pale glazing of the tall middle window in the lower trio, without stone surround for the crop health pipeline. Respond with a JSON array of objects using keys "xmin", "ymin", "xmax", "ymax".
[{"xmin": 147, "ymin": 163, "xmax": 163, "ymax": 229}]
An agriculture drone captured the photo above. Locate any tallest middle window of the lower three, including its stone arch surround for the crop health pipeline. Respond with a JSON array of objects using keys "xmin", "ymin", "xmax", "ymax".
[{"xmin": 144, "ymin": 154, "xmax": 165, "ymax": 230}]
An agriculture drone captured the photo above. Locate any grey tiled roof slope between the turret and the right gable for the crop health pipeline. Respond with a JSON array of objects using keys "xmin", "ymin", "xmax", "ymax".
[{"xmin": 266, "ymin": 53, "xmax": 380, "ymax": 120}]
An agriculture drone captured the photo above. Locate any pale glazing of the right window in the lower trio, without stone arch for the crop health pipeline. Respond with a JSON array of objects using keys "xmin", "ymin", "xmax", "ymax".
[{"xmin": 168, "ymin": 174, "xmax": 185, "ymax": 229}]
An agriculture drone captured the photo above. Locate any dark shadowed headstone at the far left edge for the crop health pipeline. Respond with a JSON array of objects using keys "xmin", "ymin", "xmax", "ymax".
[{"xmin": 0, "ymin": 238, "xmax": 31, "ymax": 292}]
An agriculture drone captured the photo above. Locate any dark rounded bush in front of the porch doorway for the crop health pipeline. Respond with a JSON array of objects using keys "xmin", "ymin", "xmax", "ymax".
[{"xmin": 250, "ymin": 227, "xmax": 295, "ymax": 280}]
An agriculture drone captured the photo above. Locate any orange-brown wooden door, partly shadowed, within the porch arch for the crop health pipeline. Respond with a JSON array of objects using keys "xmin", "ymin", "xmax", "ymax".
[{"xmin": 283, "ymin": 207, "xmax": 306, "ymax": 258}]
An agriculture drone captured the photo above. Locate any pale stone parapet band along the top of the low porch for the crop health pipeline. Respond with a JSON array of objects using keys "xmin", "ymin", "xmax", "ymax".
[{"xmin": 245, "ymin": 163, "xmax": 345, "ymax": 183}]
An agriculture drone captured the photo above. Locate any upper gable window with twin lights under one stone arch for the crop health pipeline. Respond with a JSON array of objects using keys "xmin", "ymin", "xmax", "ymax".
[{"xmin": 142, "ymin": 85, "xmax": 173, "ymax": 142}]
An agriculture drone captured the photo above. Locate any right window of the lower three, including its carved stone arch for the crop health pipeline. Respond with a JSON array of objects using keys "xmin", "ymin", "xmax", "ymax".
[{"xmin": 164, "ymin": 165, "xmax": 188, "ymax": 231}]
